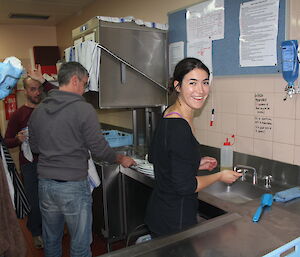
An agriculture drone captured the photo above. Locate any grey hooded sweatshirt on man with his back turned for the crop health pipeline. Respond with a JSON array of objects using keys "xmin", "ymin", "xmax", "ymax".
[{"xmin": 28, "ymin": 90, "xmax": 116, "ymax": 181}]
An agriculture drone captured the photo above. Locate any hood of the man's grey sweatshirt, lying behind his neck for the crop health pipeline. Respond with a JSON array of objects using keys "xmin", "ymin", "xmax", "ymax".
[{"xmin": 41, "ymin": 89, "xmax": 85, "ymax": 114}]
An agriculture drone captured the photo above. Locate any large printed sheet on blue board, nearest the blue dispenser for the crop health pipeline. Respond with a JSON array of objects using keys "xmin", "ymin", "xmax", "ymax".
[{"xmin": 239, "ymin": 0, "xmax": 279, "ymax": 67}]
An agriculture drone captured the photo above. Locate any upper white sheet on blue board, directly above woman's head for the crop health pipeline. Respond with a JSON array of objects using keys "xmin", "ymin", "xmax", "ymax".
[{"xmin": 186, "ymin": 0, "xmax": 224, "ymax": 41}]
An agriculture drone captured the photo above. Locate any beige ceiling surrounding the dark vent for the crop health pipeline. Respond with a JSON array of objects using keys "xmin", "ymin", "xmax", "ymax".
[{"xmin": 0, "ymin": 0, "xmax": 94, "ymax": 26}]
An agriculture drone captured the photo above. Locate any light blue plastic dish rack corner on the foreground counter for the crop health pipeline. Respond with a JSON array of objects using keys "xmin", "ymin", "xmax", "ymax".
[{"xmin": 262, "ymin": 237, "xmax": 300, "ymax": 257}]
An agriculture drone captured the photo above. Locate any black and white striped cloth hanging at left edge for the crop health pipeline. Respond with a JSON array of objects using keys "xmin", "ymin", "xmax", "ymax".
[{"xmin": 0, "ymin": 136, "xmax": 30, "ymax": 219}]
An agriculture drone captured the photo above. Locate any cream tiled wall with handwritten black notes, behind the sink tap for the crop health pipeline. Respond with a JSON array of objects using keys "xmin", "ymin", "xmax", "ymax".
[{"xmin": 195, "ymin": 0, "xmax": 300, "ymax": 165}]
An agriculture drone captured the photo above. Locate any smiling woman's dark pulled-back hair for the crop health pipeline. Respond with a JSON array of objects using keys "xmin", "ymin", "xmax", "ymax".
[{"xmin": 169, "ymin": 57, "xmax": 210, "ymax": 93}]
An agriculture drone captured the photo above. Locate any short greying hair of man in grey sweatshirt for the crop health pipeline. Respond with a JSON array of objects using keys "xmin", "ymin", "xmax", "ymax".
[{"xmin": 57, "ymin": 62, "xmax": 89, "ymax": 87}]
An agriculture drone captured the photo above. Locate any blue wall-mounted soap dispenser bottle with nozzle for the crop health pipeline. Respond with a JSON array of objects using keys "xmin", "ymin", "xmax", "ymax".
[{"xmin": 281, "ymin": 40, "xmax": 300, "ymax": 100}]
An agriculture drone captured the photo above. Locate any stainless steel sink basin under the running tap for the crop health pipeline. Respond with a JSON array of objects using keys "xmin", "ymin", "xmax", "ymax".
[{"xmin": 202, "ymin": 180, "xmax": 273, "ymax": 204}]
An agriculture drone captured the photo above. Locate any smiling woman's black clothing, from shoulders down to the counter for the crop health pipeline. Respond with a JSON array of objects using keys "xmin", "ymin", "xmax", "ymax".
[{"xmin": 145, "ymin": 118, "xmax": 201, "ymax": 235}]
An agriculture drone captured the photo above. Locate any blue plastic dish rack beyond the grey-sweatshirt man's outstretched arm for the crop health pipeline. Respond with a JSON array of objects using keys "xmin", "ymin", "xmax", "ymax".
[{"xmin": 102, "ymin": 130, "xmax": 133, "ymax": 147}]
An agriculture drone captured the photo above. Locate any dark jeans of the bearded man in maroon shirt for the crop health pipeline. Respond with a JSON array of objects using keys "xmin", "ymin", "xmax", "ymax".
[{"xmin": 21, "ymin": 162, "xmax": 42, "ymax": 236}]
